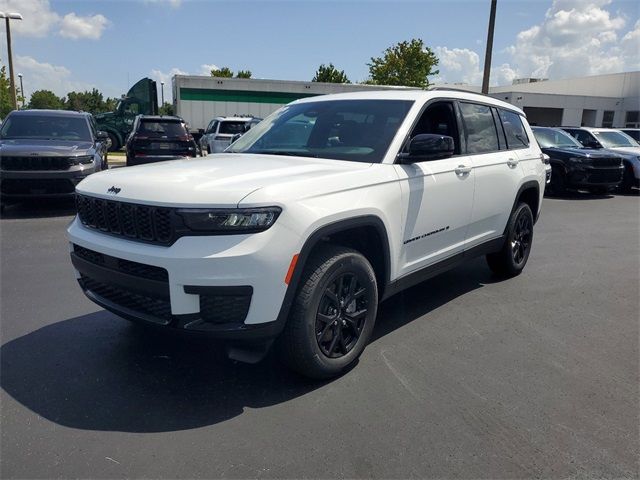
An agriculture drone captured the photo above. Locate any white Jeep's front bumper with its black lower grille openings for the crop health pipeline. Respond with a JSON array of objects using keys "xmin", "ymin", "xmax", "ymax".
[{"xmin": 68, "ymin": 218, "xmax": 295, "ymax": 340}]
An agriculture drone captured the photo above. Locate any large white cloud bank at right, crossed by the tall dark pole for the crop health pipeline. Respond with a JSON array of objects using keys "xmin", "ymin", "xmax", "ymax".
[{"xmin": 434, "ymin": 0, "xmax": 640, "ymax": 85}]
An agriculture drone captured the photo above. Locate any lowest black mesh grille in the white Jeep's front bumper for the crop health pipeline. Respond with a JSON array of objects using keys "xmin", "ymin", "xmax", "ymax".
[{"xmin": 80, "ymin": 275, "xmax": 173, "ymax": 322}]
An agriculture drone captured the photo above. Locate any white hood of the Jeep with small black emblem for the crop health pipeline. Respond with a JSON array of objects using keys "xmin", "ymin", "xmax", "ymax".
[{"xmin": 76, "ymin": 153, "xmax": 371, "ymax": 207}]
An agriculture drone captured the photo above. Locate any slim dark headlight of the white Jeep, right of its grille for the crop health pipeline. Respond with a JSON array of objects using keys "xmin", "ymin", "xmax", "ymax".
[{"xmin": 178, "ymin": 207, "xmax": 282, "ymax": 234}]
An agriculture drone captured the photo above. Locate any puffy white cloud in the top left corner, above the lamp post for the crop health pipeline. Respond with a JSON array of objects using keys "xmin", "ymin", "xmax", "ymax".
[{"xmin": 0, "ymin": 0, "xmax": 110, "ymax": 40}]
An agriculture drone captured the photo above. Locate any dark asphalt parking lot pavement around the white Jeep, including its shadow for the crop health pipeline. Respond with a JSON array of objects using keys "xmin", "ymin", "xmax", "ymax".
[{"xmin": 0, "ymin": 194, "xmax": 640, "ymax": 478}]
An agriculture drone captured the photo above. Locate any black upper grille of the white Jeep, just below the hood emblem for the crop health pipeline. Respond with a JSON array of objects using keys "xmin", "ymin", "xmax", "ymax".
[{"xmin": 76, "ymin": 195, "xmax": 176, "ymax": 245}]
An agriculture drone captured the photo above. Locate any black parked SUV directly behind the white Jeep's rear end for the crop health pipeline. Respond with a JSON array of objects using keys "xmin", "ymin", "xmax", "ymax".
[{"xmin": 531, "ymin": 127, "xmax": 624, "ymax": 195}]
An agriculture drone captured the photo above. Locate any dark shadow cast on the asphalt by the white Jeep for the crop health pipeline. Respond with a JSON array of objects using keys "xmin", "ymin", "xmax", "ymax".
[{"xmin": 0, "ymin": 262, "xmax": 493, "ymax": 433}]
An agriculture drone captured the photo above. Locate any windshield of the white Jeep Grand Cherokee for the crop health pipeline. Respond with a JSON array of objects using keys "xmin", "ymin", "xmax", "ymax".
[{"xmin": 227, "ymin": 100, "xmax": 413, "ymax": 163}]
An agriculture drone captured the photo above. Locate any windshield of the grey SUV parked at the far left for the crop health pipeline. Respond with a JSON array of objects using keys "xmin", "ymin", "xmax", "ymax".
[{"xmin": 0, "ymin": 114, "xmax": 92, "ymax": 142}]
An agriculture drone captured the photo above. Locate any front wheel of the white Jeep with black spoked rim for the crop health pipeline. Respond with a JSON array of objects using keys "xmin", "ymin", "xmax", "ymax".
[{"xmin": 276, "ymin": 245, "xmax": 378, "ymax": 379}]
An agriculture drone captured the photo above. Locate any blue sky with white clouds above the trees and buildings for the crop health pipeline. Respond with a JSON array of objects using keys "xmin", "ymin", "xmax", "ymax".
[{"xmin": 0, "ymin": 0, "xmax": 640, "ymax": 101}]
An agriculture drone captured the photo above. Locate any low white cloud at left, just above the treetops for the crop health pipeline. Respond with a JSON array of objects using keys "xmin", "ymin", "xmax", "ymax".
[{"xmin": 15, "ymin": 55, "xmax": 94, "ymax": 98}]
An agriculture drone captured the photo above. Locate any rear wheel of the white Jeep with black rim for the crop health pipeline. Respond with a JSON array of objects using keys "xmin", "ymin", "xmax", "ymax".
[{"xmin": 486, "ymin": 203, "xmax": 533, "ymax": 278}]
